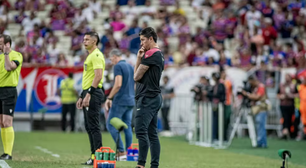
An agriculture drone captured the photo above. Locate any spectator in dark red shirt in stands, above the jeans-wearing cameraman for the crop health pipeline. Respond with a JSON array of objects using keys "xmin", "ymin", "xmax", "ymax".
[{"xmin": 262, "ymin": 18, "xmax": 277, "ymax": 45}]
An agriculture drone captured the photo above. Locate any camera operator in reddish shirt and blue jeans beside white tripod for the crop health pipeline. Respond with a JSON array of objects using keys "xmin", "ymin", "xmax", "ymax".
[{"xmin": 242, "ymin": 76, "xmax": 269, "ymax": 148}]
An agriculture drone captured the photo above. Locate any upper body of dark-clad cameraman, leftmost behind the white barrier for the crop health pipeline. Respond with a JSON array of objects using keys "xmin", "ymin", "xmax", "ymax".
[{"xmin": 191, "ymin": 76, "xmax": 211, "ymax": 102}]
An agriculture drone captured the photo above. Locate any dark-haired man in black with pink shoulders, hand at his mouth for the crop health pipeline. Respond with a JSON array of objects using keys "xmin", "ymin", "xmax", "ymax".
[{"xmin": 134, "ymin": 27, "xmax": 164, "ymax": 168}]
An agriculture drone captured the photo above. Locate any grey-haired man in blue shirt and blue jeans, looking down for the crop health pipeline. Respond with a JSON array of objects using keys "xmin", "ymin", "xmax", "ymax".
[{"xmin": 105, "ymin": 49, "xmax": 135, "ymax": 160}]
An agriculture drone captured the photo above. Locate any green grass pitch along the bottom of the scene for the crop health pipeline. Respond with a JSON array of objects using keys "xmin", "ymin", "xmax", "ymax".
[{"xmin": 0, "ymin": 132, "xmax": 306, "ymax": 168}]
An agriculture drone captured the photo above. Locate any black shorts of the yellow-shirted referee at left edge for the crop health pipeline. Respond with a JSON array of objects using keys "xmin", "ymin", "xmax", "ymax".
[{"xmin": 0, "ymin": 87, "xmax": 17, "ymax": 117}]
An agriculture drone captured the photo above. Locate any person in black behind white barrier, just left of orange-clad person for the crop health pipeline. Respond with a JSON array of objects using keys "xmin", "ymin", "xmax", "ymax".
[{"xmin": 207, "ymin": 72, "xmax": 225, "ymax": 140}]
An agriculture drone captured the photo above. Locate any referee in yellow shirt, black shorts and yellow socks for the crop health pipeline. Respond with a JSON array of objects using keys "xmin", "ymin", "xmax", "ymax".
[{"xmin": 0, "ymin": 35, "xmax": 23, "ymax": 160}]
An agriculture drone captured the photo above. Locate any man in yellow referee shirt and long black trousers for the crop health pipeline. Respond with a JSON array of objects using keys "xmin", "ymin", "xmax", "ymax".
[{"xmin": 77, "ymin": 32, "xmax": 105, "ymax": 165}]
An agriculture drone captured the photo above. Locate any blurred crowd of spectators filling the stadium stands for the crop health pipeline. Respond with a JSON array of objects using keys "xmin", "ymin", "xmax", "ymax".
[{"xmin": 0, "ymin": 0, "xmax": 306, "ymax": 69}]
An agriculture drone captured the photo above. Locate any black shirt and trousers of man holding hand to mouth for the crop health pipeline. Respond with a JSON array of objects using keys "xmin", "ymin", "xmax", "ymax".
[{"xmin": 135, "ymin": 48, "xmax": 164, "ymax": 168}]
